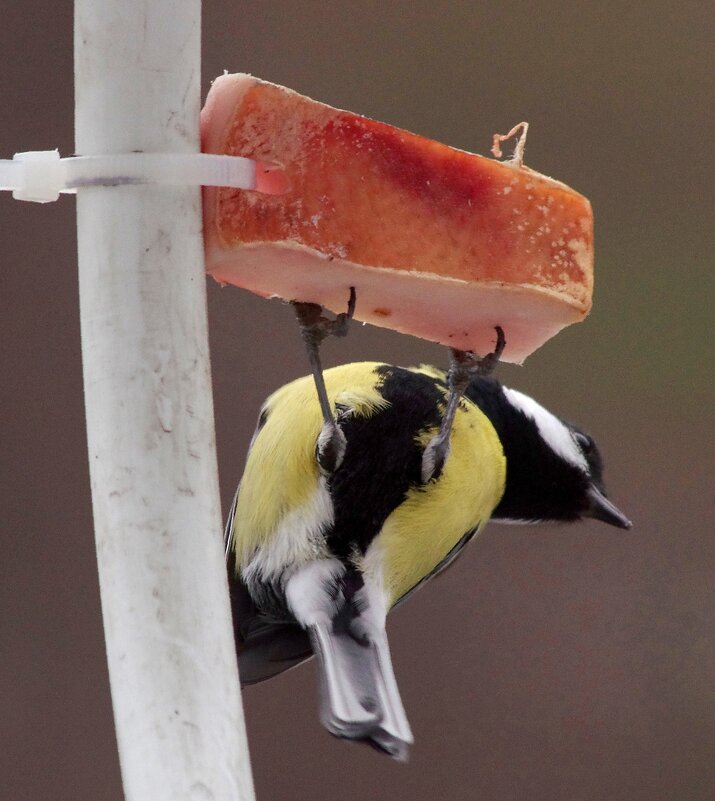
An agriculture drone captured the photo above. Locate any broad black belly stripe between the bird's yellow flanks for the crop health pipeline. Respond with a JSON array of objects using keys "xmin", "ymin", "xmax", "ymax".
[{"xmin": 327, "ymin": 365, "xmax": 444, "ymax": 560}]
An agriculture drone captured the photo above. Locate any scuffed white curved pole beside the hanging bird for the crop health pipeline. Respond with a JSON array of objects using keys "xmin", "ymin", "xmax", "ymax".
[{"xmin": 75, "ymin": 6, "xmax": 254, "ymax": 801}]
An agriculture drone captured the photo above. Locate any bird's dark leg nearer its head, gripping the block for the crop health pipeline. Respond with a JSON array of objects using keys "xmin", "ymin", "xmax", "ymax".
[{"xmin": 422, "ymin": 326, "xmax": 506, "ymax": 484}]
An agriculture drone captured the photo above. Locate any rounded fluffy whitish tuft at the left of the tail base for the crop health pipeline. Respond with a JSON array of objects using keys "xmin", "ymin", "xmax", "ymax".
[{"xmin": 285, "ymin": 559, "xmax": 345, "ymax": 627}]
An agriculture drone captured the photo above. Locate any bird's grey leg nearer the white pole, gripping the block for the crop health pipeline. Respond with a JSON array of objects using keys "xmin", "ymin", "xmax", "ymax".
[{"xmin": 293, "ymin": 287, "xmax": 355, "ymax": 473}]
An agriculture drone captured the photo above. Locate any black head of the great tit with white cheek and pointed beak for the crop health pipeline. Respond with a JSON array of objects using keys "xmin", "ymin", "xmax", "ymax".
[{"xmin": 480, "ymin": 384, "xmax": 631, "ymax": 529}]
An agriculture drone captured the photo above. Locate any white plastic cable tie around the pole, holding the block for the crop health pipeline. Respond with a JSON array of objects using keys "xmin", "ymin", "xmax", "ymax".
[{"xmin": 0, "ymin": 150, "xmax": 258, "ymax": 203}]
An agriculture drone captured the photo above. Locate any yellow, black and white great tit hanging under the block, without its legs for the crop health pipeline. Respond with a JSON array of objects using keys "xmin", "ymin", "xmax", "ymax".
[{"xmin": 226, "ymin": 362, "xmax": 631, "ymax": 759}]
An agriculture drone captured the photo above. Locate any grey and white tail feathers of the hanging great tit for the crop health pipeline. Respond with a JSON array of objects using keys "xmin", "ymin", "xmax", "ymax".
[{"xmin": 308, "ymin": 621, "xmax": 413, "ymax": 761}]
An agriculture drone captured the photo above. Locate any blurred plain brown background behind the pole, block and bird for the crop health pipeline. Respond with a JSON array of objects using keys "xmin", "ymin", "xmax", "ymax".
[{"xmin": 0, "ymin": 0, "xmax": 715, "ymax": 801}]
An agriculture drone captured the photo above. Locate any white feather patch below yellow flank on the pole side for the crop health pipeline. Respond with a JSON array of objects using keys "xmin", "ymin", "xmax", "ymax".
[{"xmin": 241, "ymin": 477, "xmax": 335, "ymax": 584}]
